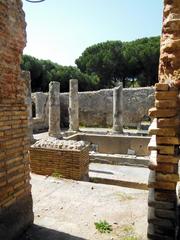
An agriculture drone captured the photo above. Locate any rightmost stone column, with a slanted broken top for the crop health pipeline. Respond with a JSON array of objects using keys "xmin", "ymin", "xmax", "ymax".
[{"xmin": 113, "ymin": 84, "xmax": 123, "ymax": 133}]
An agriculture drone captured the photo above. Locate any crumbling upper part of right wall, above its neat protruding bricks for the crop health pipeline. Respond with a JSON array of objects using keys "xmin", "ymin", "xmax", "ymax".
[{"xmin": 159, "ymin": 0, "xmax": 180, "ymax": 87}]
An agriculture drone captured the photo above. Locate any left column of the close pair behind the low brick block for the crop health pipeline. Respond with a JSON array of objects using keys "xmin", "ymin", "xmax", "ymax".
[{"xmin": 49, "ymin": 82, "xmax": 61, "ymax": 138}]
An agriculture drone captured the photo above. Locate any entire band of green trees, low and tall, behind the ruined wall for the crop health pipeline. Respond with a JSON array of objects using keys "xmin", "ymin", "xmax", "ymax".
[{"xmin": 21, "ymin": 37, "xmax": 160, "ymax": 92}]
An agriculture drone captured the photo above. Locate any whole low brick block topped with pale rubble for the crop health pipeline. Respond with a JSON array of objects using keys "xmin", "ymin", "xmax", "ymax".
[{"xmin": 30, "ymin": 137, "xmax": 89, "ymax": 180}]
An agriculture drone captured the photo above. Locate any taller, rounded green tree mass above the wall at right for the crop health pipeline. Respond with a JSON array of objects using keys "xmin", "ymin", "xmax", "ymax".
[{"xmin": 75, "ymin": 37, "xmax": 160, "ymax": 88}]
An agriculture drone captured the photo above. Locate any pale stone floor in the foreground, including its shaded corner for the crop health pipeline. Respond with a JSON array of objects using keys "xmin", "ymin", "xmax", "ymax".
[{"xmin": 19, "ymin": 174, "xmax": 147, "ymax": 240}]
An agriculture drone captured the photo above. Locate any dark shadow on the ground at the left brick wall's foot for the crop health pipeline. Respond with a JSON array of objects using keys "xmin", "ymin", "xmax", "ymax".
[{"xmin": 20, "ymin": 224, "xmax": 86, "ymax": 240}]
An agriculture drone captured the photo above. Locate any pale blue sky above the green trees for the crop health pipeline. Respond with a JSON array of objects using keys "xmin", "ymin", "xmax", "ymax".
[{"xmin": 23, "ymin": 0, "xmax": 163, "ymax": 65}]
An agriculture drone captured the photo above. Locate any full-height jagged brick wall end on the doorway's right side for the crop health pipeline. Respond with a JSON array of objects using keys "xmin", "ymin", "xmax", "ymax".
[{"xmin": 148, "ymin": 0, "xmax": 180, "ymax": 240}]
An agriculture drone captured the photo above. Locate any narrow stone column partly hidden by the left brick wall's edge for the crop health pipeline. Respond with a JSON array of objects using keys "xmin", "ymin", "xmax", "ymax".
[{"xmin": 21, "ymin": 71, "xmax": 35, "ymax": 143}]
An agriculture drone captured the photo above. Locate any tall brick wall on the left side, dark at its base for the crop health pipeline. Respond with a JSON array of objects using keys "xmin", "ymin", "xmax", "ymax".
[{"xmin": 0, "ymin": 0, "xmax": 33, "ymax": 240}]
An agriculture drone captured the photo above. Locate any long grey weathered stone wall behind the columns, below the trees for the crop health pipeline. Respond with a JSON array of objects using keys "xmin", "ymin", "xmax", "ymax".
[{"xmin": 32, "ymin": 87, "xmax": 154, "ymax": 130}]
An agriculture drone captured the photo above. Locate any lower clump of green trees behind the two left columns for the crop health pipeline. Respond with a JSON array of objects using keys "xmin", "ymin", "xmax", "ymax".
[{"xmin": 21, "ymin": 55, "xmax": 99, "ymax": 92}]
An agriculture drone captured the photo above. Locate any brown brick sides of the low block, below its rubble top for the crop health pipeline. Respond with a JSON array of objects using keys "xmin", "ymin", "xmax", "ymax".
[{"xmin": 30, "ymin": 140, "xmax": 89, "ymax": 180}]
